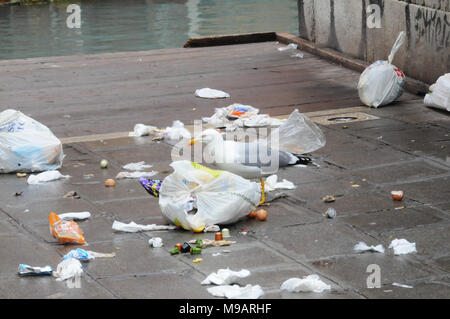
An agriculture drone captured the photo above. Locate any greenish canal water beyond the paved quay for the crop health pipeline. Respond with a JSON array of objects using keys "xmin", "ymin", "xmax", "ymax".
[{"xmin": 0, "ymin": 0, "xmax": 298, "ymax": 59}]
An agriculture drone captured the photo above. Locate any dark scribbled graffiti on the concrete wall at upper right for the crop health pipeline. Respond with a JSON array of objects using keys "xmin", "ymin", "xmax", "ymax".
[{"xmin": 414, "ymin": 8, "xmax": 450, "ymax": 51}]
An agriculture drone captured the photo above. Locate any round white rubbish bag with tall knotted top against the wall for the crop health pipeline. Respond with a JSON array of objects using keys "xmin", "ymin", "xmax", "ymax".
[{"xmin": 358, "ymin": 31, "xmax": 406, "ymax": 108}]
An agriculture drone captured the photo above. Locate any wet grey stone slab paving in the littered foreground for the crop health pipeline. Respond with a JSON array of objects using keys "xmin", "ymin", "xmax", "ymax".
[{"xmin": 0, "ymin": 40, "xmax": 450, "ymax": 298}]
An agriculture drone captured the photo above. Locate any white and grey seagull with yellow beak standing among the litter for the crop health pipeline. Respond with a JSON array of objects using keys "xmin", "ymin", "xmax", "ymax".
[{"xmin": 188, "ymin": 129, "xmax": 311, "ymax": 204}]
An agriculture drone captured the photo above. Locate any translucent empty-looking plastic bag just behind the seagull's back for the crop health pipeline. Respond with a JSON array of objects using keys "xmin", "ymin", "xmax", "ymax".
[{"xmin": 268, "ymin": 110, "xmax": 326, "ymax": 154}]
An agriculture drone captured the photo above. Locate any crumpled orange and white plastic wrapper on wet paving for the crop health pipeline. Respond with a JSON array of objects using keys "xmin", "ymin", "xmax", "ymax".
[{"xmin": 48, "ymin": 213, "xmax": 86, "ymax": 244}]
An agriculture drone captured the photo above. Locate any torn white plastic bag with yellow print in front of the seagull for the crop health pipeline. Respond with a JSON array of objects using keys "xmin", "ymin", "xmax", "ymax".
[{"xmin": 159, "ymin": 161, "xmax": 261, "ymax": 232}]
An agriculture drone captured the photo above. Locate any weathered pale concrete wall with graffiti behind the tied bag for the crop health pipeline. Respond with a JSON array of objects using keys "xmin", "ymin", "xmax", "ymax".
[{"xmin": 298, "ymin": 0, "xmax": 450, "ymax": 84}]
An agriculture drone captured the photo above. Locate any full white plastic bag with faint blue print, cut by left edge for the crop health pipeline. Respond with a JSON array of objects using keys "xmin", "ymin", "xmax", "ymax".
[{"xmin": 0, "ymin": 109, "xmax": 64, "ymax": 173}]
